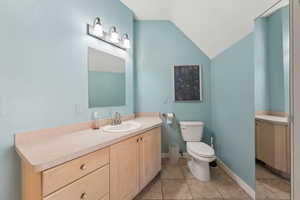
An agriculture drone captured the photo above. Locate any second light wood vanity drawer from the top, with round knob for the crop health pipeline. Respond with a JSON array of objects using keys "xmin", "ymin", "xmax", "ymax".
[{"xmin": 43, "ymin": 165, "xmax": 109, "ymax": 200}]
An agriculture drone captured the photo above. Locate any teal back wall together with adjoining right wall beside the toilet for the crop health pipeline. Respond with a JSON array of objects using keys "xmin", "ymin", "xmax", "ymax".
[{"xmin": 134, "ymin": 21, "xmax": 255, "ymax": 188}]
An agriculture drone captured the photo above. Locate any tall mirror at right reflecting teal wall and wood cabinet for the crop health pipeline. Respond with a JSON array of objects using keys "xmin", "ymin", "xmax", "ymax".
[{"xmin": 255, "ymin": 0, "xmax": 292, "ymax": 200}]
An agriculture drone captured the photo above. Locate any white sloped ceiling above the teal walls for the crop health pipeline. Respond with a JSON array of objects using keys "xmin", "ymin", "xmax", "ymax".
[{"xmin": 121, "ymin": 0, "xmax": 278, "ymax": 59}]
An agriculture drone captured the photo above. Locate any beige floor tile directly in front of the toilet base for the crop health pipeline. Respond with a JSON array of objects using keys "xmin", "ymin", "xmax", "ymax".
[{"xmin": 187, "ymin": 179, "xmax": 222, "ymax": 199}]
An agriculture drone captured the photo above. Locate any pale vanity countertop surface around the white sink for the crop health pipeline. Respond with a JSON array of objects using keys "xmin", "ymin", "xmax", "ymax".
[{"xmin": 16, "ymin": 117, "xmax": 162, "ymax": 172}]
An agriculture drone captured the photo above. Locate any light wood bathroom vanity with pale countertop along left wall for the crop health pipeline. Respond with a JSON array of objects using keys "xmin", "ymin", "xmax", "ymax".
[{"xmin": 15, "ymin": 116, "xmax": 162, "ymax": 200}]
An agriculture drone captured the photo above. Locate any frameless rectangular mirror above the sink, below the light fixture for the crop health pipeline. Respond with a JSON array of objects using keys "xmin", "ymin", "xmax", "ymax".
[{"xmin": 88, "ymin": 47, "xmax": 126, "ymax": 108}]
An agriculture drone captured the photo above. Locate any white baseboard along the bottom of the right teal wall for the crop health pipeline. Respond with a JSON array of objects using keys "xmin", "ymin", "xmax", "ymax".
[{"xmin": 217, "ymin": 159, "xmax": 255, "ymax": 199}]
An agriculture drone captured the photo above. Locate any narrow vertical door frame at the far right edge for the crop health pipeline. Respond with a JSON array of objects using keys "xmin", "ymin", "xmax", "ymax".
[{"xmin": 290, "ymin": 0, "xmax": 300, "ymax": 200}]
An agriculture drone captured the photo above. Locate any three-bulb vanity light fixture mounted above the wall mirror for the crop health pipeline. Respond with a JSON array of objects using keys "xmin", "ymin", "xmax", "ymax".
[{"xmin": 87, "ymin": 17, "xmax": 131, "ymax": 51}]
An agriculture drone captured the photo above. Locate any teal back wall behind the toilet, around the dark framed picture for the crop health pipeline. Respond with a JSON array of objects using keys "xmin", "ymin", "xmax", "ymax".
[{"xmin": 135, "ymin": 21, "xmax": 211, "ymax": 152}]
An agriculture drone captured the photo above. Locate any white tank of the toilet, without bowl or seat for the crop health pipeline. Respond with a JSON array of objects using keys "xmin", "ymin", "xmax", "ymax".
[{"xmin": 180, "ymin": 121, "xmax": 204, "ymax": 142}]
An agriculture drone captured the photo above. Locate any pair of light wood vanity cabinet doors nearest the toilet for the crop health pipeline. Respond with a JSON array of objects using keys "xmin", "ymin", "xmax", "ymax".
[{"xmin": 110, "ymin": 128, "xmax": 161, "ymax": 200}]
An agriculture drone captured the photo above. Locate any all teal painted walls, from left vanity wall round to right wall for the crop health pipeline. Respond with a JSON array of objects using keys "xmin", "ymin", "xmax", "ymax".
[{"xmin": 0, "ymin": 0, "xmax": 268, "ymax": 196}]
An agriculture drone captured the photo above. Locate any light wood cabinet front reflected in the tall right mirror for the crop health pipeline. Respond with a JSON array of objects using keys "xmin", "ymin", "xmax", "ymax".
[{"xmin": 255, "ymin": 120, "xmax": 291, "ymax": 173}]
